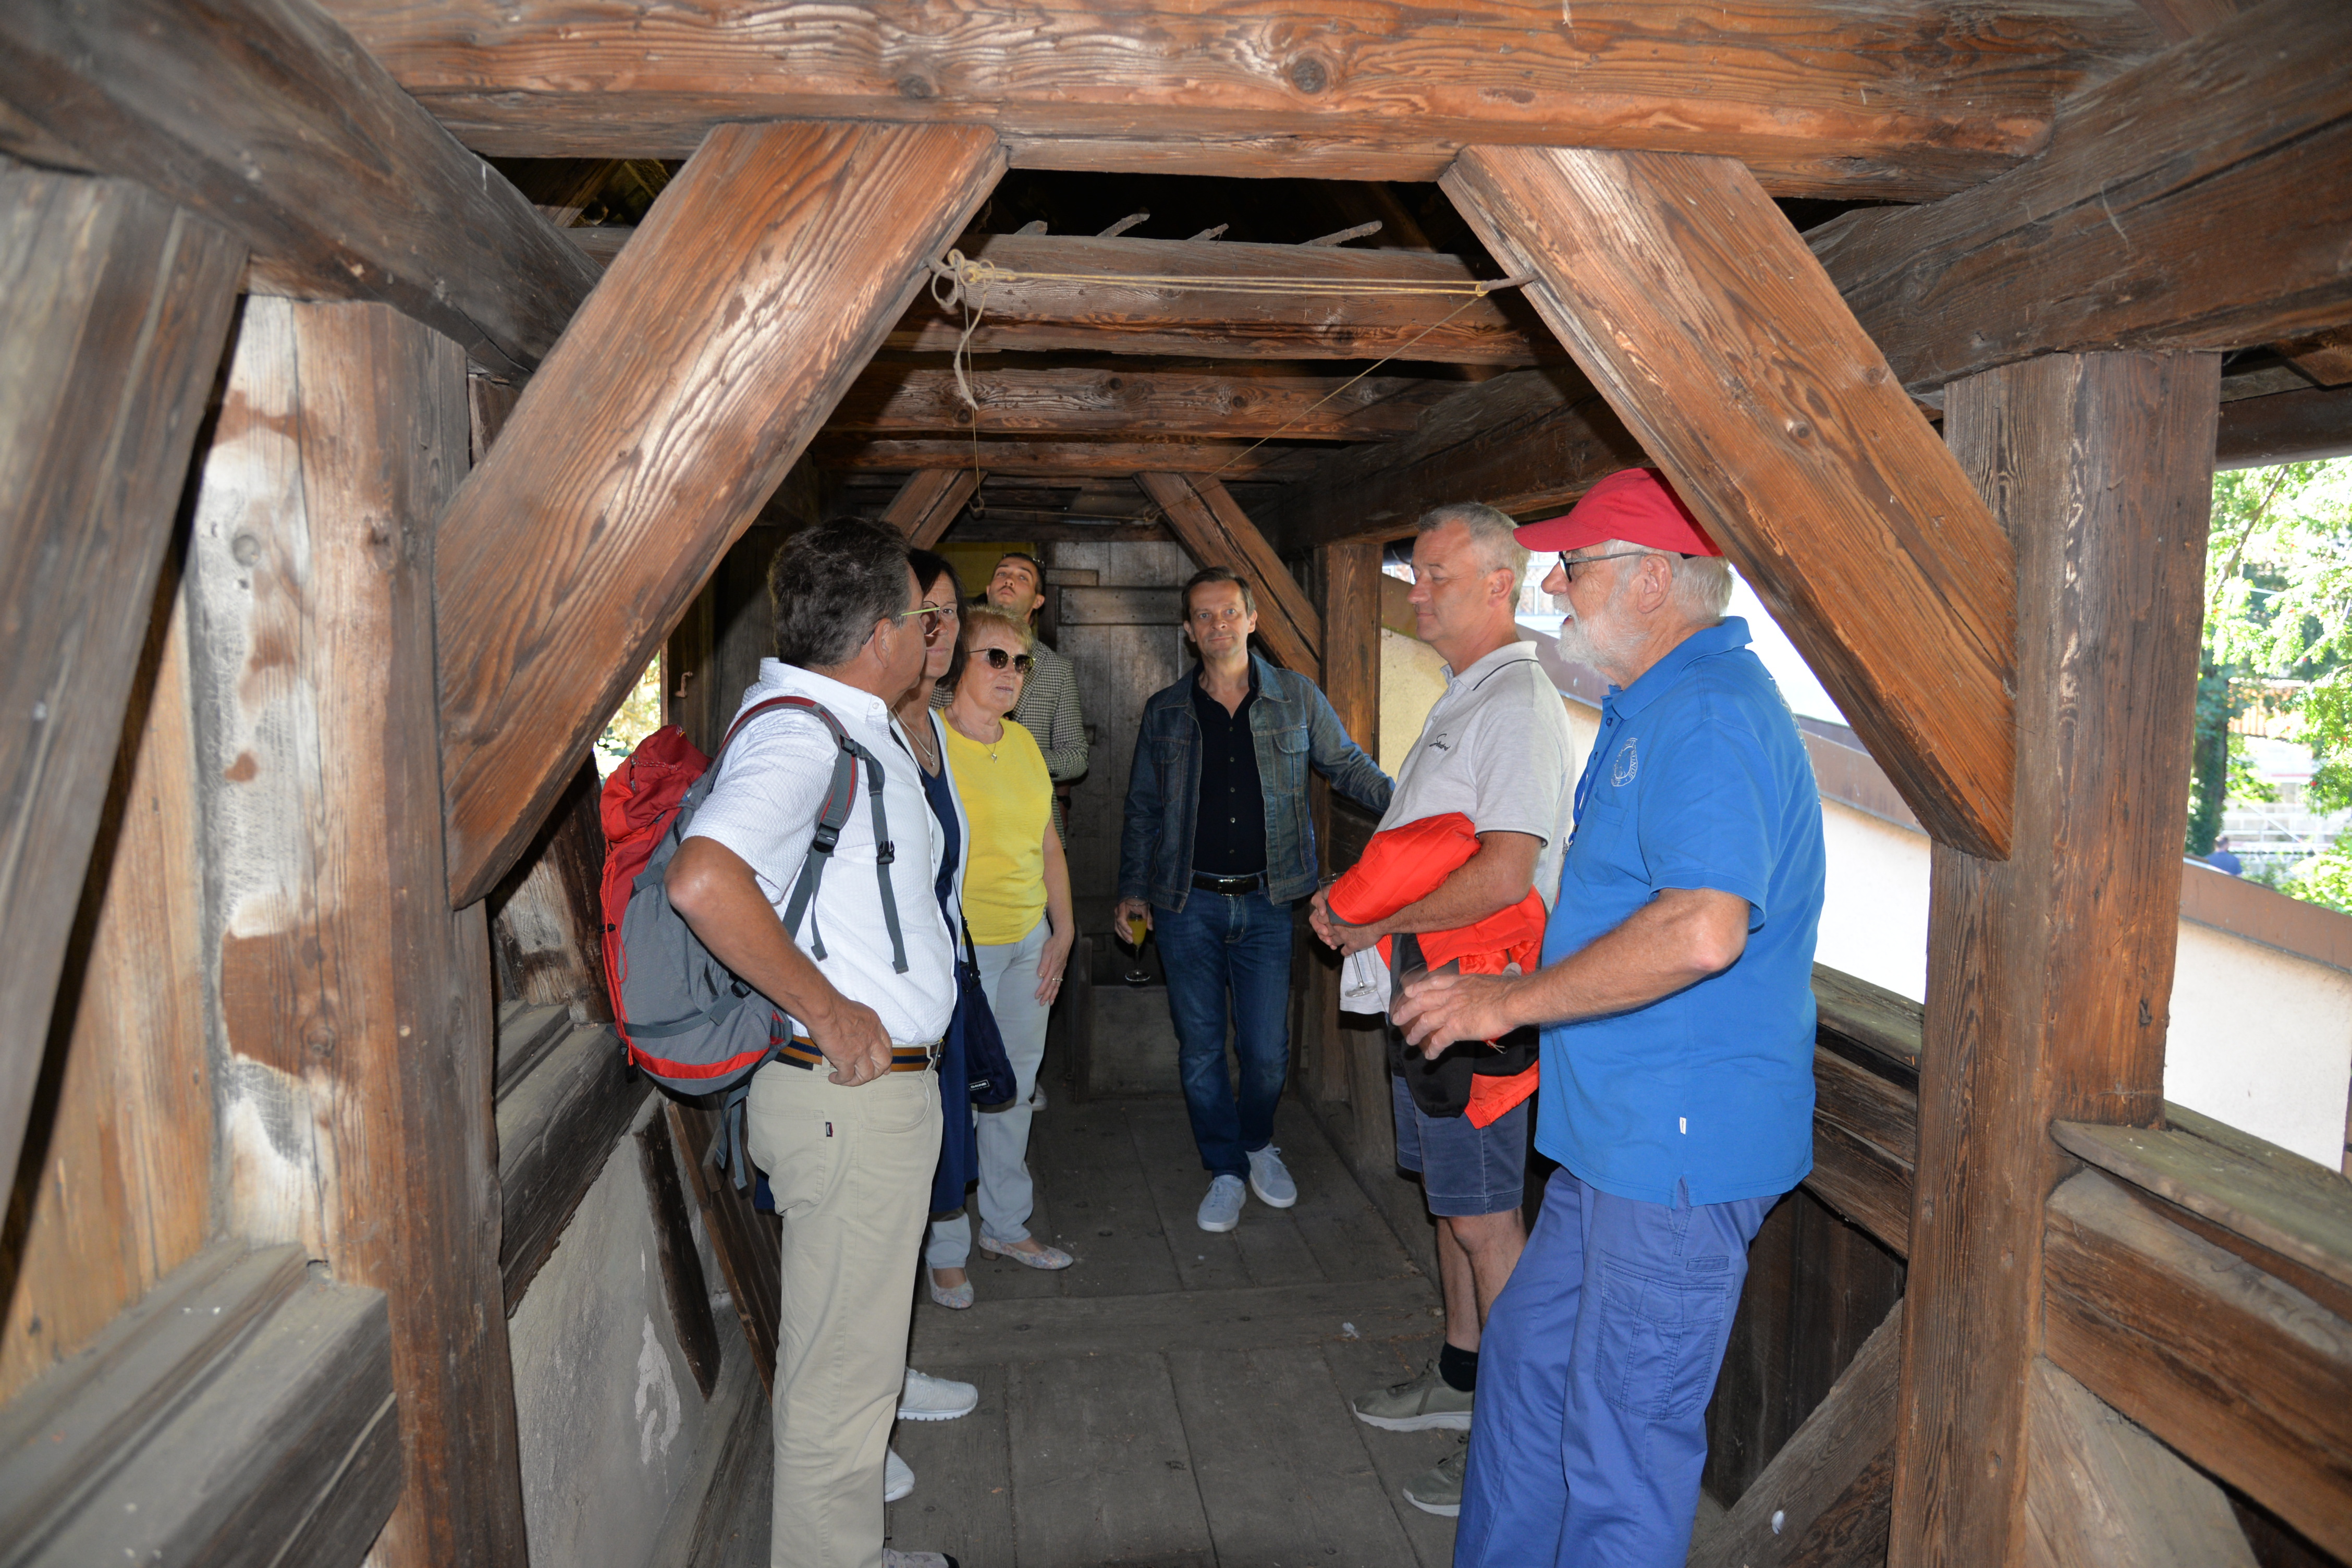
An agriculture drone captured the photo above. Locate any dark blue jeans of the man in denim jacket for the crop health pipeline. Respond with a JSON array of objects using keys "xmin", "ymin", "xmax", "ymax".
[{"xmin": 1153, "ymin": 886, "xmax": 1291, "ymax": 1175}]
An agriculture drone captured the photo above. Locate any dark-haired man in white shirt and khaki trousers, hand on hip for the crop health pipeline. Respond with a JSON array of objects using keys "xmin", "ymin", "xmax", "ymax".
[{"xmin": 668, "ymin": 517, "xmax": 955, "ymax": 1568}]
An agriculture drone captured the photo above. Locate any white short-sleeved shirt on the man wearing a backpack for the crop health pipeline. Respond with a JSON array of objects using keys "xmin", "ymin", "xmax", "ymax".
[{"xmin": 687, "ymin": 658, "xmax": 955, "ymax": 1046}]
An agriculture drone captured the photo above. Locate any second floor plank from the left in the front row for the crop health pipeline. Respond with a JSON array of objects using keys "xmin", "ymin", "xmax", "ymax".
[{"xmin": 1009, "ymin": 1354, "xmax": 1216, "ymax": 1568}]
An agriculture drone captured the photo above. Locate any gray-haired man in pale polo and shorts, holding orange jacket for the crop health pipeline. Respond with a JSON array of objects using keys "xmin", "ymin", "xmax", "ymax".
[{"xmin": 1313, "ymin": 503, "xmax": 1574, "ymax": 1514}]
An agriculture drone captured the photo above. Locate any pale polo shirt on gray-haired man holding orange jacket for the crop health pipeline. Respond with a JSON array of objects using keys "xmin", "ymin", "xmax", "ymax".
[{"xmin": 1381, "ymin": 642, "xmax": 1576, "ymax": 910}]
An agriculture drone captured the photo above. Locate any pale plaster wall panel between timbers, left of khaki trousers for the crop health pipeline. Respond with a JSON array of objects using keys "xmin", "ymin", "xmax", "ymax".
[{"xmin": 506, "ymin": 1100, "xmax": 705, "ymax": 1568}]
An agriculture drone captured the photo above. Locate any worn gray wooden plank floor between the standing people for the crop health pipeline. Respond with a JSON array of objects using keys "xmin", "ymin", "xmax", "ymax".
[{"xmin": 680, "ymin": 1084, "xmax": 1456, "ymax": 1568}]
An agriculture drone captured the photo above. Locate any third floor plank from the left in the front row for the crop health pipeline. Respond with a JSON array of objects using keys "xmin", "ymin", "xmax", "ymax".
[{"xmin": 1169, "ymin": 1345, "xmax": 1418, "ymax": 1568}]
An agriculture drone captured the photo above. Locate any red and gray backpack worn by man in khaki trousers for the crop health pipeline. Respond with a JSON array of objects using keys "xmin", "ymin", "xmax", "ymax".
[{"xmin": 600, "ymin": 696, "xmax": 905, "ymax": 1096}]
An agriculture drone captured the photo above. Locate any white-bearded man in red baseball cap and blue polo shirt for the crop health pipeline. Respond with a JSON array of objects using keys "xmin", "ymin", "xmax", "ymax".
[{"xmin": 1395, "ymin": 468, "xmax": 1825, "ymax": 1568}]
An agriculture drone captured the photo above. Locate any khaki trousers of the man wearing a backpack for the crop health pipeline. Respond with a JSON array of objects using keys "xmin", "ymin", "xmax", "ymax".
[{"xmin": 745, "ymin": 1062, "xmax": 938, "ymax": 1568}]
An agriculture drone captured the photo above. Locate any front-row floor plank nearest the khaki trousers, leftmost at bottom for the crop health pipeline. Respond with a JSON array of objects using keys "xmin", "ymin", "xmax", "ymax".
[{"xmin": 882, "ymin": 1366, "xmax": 1014, "ymax": 1568}]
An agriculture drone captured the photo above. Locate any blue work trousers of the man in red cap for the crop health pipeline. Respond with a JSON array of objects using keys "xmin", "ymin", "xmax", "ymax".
[{"xmin": 1453, "ymin": 1171, "xmax": 1778, "ymax": 1568}]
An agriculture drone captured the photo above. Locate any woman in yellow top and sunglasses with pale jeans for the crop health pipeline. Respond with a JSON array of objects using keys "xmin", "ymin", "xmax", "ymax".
[{"xmin": 924, "ymin": 604, "xmax": 1077, "ymax": 1307}]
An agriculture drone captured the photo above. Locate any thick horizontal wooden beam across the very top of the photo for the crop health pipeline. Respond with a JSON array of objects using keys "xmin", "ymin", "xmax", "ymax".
[{"xmin": 334, "ymin": 0, "xmax": 2159, "ymax": 196}]
